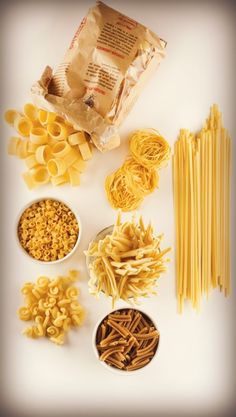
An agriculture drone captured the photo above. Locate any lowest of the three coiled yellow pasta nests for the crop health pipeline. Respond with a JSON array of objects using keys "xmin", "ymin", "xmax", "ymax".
[{"xmin": 105, "ymin": 168, "xmax": 143, "ymax": 211}]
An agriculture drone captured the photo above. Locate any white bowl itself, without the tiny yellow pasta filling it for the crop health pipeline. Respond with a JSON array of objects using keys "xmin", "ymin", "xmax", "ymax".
[{"xmin": 15, "ymin": 197, "xmax": 82, "ymax": 265}]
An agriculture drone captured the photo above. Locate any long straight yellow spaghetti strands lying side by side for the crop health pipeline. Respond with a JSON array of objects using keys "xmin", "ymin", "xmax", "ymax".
[{"xmin": 173, "ymin": 105, "xmax": 231, "ymax": 312}]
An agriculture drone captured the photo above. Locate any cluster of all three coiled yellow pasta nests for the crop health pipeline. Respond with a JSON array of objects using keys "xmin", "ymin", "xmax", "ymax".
[{"xmin": 105, "ymin": 129, "xmax": 170, "ymax": 211}]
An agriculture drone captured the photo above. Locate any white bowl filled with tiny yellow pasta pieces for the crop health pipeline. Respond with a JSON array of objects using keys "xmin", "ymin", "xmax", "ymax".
[{"xmin": 16, "ymin": 197, "xmax": 82, "ymax": 264}]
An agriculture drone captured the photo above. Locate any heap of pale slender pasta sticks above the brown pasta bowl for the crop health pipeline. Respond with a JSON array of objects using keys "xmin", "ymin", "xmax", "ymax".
[{"xmin": 85, "ymin": 214, "xmax": 170, "ymax": 305}]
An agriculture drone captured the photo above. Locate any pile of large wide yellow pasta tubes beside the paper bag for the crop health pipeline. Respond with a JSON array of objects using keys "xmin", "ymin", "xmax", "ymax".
[{"xmin": 5, "ymin": 103, "xmax": 92, "ymax": 189}]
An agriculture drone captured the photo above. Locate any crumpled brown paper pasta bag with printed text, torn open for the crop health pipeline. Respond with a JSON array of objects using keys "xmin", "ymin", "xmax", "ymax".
[{"xmin": 32, "ymin": 2, "xmax": 166, "ymax": 151}]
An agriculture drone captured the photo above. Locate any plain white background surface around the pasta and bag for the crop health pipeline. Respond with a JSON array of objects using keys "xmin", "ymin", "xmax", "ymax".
[{"xmin": 1, "ymin": 0, "xmax": 235, "ymax": 417}]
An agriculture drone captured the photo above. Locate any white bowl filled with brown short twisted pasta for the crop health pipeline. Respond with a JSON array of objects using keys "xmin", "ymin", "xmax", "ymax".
[{"xmin": 93, "ymin": 307, "xmax": 160, "ymax": 374}]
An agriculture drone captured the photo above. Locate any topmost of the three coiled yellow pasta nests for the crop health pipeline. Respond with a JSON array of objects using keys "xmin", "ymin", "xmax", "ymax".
[{"xmin": 130, "ymin": 129, "xmax": 170, "ymax": 169}]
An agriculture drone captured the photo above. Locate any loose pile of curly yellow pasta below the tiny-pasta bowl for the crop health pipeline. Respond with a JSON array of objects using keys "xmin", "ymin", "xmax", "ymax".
[{"xmin": 18, "ymin": 271, "xmax": 84, "ymax": 345}]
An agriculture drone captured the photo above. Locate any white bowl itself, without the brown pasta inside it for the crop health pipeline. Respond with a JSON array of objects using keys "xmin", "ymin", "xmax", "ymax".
[{"xmin": 92, "ymin": 306, "xmax": 160, "ymax": 375}]
